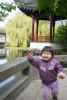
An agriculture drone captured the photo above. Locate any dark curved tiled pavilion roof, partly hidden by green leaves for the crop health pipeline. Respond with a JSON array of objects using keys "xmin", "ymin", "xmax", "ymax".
[{"xmin": 14, "ymin": 0, "xmax": 67, "ymax": 21}]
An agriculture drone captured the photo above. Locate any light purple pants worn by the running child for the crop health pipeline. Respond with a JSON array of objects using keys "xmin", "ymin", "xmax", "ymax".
[{"xmin": 43, "ymin": 80, "xmax": 59, "ymax": 100}]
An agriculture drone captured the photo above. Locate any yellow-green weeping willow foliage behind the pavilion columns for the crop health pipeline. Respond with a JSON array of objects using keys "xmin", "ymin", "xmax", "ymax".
[{"xmin": 6, "ymin": 13, "xmax": 49, "ymax": 48}]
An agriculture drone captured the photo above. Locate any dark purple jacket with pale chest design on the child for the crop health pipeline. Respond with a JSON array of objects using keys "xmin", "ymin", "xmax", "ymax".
[{"xmin": 28, "ymin": 58, "xmax": 63, "ymax": 85}]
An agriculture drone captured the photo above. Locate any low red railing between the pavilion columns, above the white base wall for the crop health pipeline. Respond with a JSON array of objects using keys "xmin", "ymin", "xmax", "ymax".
[{"xmin": 29, "ymin": 36, "xmax": 50, "ymax": 42}]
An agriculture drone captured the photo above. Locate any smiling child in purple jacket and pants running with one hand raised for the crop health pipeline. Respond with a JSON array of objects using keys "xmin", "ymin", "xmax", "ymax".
[{"xmin": 27, "ymin": 46, "xmax": 65, "ymax": 100}]
